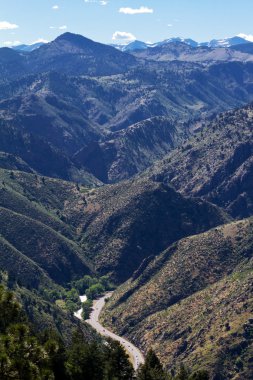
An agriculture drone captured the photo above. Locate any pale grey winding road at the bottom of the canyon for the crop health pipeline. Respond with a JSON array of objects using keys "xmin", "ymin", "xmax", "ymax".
[{"xmin": 75, "ymin": 292, "xmax": 144, "ymax": 371}]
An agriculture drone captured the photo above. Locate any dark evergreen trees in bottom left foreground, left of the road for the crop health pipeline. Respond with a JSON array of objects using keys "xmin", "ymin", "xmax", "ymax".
[{"xmin": 0, "ymin": 286, "xmax": 136, "ymax": 380}]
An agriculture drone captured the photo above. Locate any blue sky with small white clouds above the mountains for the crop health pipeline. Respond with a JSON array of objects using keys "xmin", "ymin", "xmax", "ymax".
[{"xmin": 0, "ymin": 0, "xmax": 253, "ymax": 46}]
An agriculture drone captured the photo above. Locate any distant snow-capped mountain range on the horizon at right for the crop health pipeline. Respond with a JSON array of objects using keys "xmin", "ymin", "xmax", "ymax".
[{"xmin": 112, "ymin": 34, "xmax": 252, "ymax": 52}]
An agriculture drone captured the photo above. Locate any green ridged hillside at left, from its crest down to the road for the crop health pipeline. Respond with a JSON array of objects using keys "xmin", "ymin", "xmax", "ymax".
[{"xmin": 0, "ymin": 169, "xmax": 103, "ymax": 343}]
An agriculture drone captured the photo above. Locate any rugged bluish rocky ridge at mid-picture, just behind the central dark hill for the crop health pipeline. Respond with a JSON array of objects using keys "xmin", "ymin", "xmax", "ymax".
[{"xmin": 74, "ymin": 117, "xmax": 187, "ymax": 183}]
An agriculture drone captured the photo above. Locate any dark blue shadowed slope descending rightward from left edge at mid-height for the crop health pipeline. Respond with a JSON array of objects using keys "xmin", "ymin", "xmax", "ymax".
[{"xmin": 0, "ymin": 121, "xmax": 100, "ymax": 186}]
